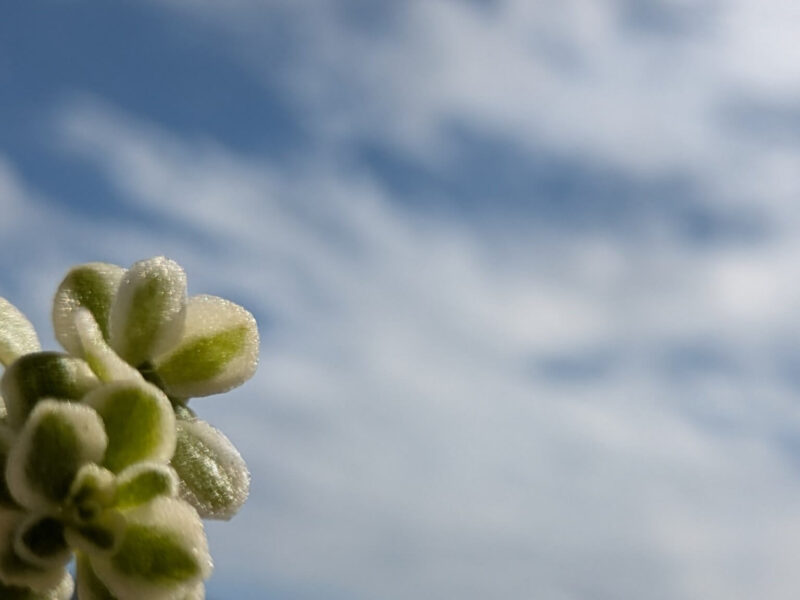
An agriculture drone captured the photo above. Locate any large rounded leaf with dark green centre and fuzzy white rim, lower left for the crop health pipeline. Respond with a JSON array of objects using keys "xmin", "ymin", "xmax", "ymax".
[{"xmin": 6, "ymin": 400, "xmax": 108, "ymax": 511}]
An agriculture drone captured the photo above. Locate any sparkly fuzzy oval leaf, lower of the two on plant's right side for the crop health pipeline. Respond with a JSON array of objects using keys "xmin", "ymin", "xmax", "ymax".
[{"xmin": 171, "ymin": 419, "xmax": 250, "ymax": 520}]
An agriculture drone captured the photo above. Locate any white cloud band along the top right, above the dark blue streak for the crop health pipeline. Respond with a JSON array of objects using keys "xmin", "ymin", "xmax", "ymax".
[{"xmin": 152, "ymin": 0, "xmax": 800, "ymax": 174}]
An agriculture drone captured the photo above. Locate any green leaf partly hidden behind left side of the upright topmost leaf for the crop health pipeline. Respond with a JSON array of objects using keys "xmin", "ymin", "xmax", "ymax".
[{"xmin": 53, "ymin": 262, "xmax": 125, "ymax": 356}]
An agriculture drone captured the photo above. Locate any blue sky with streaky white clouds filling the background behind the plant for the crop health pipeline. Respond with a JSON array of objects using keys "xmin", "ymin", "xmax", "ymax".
[{"xmin": 0, "ymin": 0, "xmax": 800, "ymax": 600}]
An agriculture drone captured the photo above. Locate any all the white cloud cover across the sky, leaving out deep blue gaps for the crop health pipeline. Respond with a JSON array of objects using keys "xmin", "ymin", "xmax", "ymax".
[{"xmin": 0, "ymin": 0, "xmax": 800, "ymax": 600}]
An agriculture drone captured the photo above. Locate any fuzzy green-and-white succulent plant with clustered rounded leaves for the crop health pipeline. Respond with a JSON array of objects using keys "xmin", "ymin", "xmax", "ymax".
[{"xmin": 0, "ymin": 257, "xmax": 259, "ymax": 600}]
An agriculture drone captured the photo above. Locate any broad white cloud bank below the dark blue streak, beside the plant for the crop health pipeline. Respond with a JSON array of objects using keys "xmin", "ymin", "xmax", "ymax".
[{"xmin": 31, "ymin": 97, "xmax": 800, "ymax": 600}]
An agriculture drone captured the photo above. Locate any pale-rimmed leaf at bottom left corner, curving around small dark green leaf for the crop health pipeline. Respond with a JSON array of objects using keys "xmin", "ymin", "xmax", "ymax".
[{"xmin": 0, "ymin": 510, "xmax": 68, "ymax": 598}]
